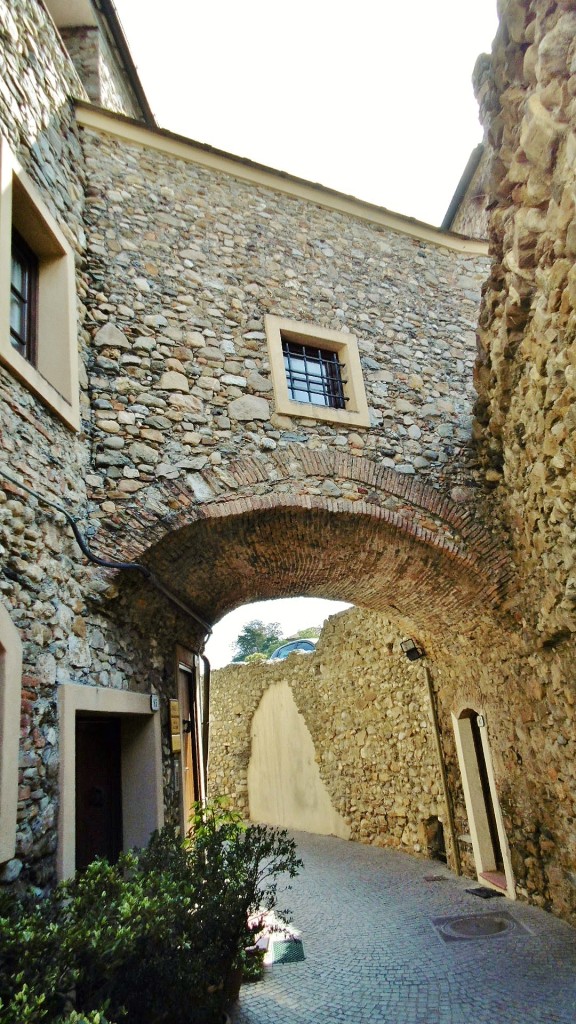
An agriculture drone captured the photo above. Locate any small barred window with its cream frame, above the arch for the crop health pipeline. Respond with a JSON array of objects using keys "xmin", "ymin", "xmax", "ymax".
[{"xmin": 264, "ymin": 315, "xmax": 370, "ymax": 427}]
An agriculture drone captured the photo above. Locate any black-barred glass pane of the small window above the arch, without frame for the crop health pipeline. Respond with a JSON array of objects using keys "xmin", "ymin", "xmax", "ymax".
[{"xmin": 282, "ymin": 337, "xmax": 347, "ymax": 409}]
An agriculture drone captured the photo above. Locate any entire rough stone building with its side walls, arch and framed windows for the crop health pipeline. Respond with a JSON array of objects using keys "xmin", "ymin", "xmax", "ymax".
[{"xmin": 0, "ymin": 0, "xmax": 576, "ymax": 919}]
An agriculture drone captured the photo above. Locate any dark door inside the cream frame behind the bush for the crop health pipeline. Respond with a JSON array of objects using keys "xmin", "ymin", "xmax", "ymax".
[{"xmin": 76, "ymin": 717, "xmax": 122, "ymax": 869}]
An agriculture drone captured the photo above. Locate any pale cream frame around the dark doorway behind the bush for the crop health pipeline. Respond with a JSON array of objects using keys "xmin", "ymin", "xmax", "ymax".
[{"xmin": 57, "ymin": 683, "xmax": 164, "ymax": 879}]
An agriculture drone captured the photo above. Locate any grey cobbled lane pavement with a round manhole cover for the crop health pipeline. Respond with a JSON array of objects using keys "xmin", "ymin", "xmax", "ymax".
[{"xmin": 233, "ymin": 833, "xmax": 576, "ymax": 1024}]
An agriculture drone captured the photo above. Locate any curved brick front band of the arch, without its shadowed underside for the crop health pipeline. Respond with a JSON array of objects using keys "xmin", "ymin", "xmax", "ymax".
[{"xmin": 94, "ymin": 444, "xmax": 507, "ymax": 565}]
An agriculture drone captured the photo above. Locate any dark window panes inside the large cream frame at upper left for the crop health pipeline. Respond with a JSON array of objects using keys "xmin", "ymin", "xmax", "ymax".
[{"xmin": 10, "ymin": 231, "xmax": 38, "ymax": 365}]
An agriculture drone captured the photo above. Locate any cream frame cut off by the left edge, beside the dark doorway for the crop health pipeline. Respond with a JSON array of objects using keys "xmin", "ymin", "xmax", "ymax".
[{"xmin": 0, "ymin": 604, "xmax": 22, "ymax": 863}]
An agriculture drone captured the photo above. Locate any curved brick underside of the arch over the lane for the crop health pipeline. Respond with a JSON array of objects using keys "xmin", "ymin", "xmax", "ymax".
[{"xmin": 123, "ymin": 498, "xmax": 507, "ymax": 644}]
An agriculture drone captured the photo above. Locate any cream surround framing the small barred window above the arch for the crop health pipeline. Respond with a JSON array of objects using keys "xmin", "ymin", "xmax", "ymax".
[{"xmin": 264, "ymin": 313, "xmax": 370, "ymax": 427}]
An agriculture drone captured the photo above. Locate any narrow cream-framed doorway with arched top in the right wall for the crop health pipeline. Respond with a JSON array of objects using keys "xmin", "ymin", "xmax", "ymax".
[{"xmin": 452, "ymin": 708, "xmax": 515, "ymax": 897}]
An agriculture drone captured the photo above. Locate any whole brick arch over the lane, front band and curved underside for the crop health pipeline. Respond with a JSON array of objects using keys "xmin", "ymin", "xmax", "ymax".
[{"xmin": 91, "ymin": 445, "xmax": 509, "ymax": 636}]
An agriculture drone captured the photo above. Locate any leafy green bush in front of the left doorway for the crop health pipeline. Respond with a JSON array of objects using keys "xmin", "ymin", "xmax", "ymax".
[{"xmin": 0, "ymin": 804, "xmax": 301, "ymax": 1024}]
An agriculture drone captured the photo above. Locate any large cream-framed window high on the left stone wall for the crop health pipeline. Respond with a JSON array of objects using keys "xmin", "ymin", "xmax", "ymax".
[{"xmin": 0, "ymin": 138, "xmax": 80, "ymax": 430}]
